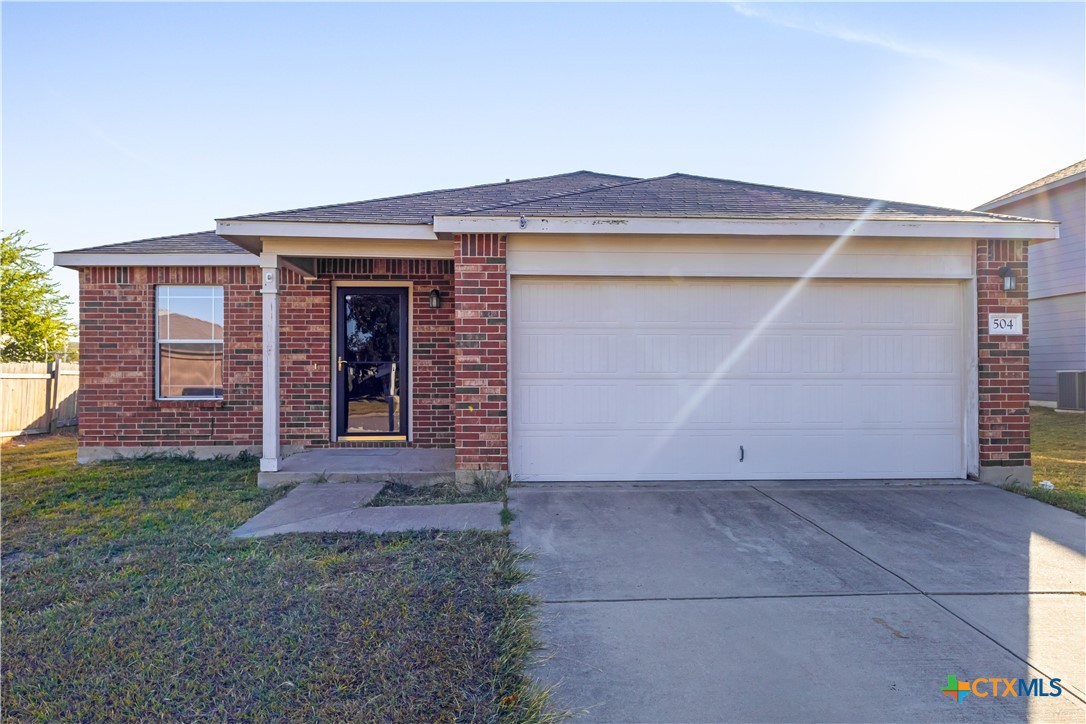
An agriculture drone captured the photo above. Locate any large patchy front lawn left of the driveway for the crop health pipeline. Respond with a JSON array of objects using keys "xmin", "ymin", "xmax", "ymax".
[{"xmin": 0, "ymin": 436, "xmax": 544, "ymax": 722}]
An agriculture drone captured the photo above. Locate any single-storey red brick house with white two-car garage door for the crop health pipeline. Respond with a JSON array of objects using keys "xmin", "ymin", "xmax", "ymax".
[{"xmin": 56, "ymin": 172, "xmax": 1058, "ymax": 482}]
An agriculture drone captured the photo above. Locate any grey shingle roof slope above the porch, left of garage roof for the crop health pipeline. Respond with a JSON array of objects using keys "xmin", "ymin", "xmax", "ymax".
[{"xmin": 229, "ymin": 170, "xmax": 636, "ymax": 224}]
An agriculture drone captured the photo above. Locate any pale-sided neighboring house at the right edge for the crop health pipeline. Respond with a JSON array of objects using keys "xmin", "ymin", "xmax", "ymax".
[{"xmin": 977, "ymin": 161, "xmax": 1086, "ymax": 407}]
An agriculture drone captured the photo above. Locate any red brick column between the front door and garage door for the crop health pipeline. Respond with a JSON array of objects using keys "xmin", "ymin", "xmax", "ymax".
[{"xmin": 454, "ymin": 233, "xmax": 509, "ymax": 484}]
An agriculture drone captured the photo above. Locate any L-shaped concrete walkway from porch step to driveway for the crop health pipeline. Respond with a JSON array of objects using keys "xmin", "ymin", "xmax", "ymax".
[{"xmin": 232, "ymin": 483, "xmax": 503, "ymax": 538}]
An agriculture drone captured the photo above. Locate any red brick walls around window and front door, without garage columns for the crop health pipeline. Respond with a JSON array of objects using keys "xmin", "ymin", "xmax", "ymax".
[{"xmin": 79, "ymin": 259, "xmax": 455, "ymax": 457}]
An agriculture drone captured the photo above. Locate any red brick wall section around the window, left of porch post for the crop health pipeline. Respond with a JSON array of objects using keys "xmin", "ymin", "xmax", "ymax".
[{"xmin": 79, "ymin": 267, "xmax": 261, "ymax": 449}]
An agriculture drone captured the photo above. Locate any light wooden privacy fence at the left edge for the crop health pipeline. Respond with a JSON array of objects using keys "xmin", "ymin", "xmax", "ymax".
[{"xmin": 0, "ymin": 361, "xmax": 79, "ymax": 437}]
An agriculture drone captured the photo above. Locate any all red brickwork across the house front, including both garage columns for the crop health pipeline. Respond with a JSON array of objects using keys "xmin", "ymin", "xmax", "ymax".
[{"xmin": 79, "ymin": 234, "xmax": 1030, "ymax": 478}]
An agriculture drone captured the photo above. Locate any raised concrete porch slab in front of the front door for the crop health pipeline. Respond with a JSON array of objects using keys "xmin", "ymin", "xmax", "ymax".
[{"xmin": 256, "ymin": 447, "xmax": 456, "ymax": 487}]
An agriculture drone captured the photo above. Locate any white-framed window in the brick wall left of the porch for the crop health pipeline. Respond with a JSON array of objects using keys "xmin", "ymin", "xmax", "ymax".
[{"xmin": 155, "ymin": 285, "xmax": 223, "ymax": 399}]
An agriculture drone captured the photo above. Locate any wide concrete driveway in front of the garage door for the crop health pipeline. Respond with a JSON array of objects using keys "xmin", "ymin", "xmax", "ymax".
[{"xmin": 510, "ymin": 482, "xmax": 1086, "ymax": 722}]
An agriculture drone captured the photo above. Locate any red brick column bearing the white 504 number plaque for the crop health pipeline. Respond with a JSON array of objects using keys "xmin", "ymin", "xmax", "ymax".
[{"xmin": 976, "ymin": 239, "xmax": 1033, "ymax": 485}]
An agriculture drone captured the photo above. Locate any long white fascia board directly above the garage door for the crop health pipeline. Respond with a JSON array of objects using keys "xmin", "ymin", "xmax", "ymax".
[{"xmin": 433, "ymin": 216, "xmax": 1060, "ymax": 239}]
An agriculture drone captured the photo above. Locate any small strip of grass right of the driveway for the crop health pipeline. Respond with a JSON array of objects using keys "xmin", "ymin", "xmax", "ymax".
[{"xmin": 1012, "ymin": 407, "xmax": 1086, "ymax": 516}]
